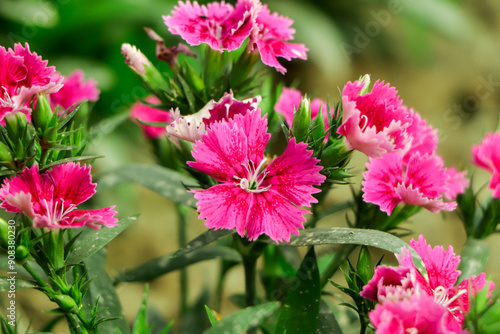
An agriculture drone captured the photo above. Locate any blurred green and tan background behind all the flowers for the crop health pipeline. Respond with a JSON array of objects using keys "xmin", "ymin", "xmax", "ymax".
[{"xmin": 0, "ymin": 0, "xmax": 500, "ymax": 327}]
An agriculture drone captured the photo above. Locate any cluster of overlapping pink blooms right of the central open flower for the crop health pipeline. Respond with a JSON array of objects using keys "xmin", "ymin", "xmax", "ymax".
[{"xmin": 338, "ymin": 77, "xmax": 469, "ymax": 215}]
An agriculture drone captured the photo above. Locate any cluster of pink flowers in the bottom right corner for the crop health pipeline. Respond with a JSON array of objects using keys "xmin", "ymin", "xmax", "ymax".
[{"xmin": 361, "ymin": 235, "xmax": 494, "ymax": 334}]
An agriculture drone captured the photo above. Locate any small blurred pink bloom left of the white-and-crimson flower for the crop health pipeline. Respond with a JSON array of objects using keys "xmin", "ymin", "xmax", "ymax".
[{"xmin": 130, "ymin": 95, "xmax": 172, "ymax": 139}]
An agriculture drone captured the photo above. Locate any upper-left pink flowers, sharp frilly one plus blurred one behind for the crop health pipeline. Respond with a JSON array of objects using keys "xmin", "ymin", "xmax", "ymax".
[{"xmin": 0, "ymin": 43, "xmax": 99, "ymax": 125}]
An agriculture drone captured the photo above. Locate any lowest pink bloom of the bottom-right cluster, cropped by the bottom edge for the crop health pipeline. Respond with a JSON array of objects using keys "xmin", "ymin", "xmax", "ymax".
[{"xmin": 369, "ymin": 294, "xmax": 458, "ymax": 334}]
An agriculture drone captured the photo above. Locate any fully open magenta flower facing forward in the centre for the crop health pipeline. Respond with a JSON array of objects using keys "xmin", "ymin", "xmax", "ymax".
[{"xmin": 188, "ymin": 111, "xmax": 325, "ymax": 242}]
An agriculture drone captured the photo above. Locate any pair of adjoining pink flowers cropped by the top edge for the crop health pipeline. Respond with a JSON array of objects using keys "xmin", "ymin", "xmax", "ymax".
[{"xmin": 163, "ymin": 0, "xmax": 308, "ymax": 74}]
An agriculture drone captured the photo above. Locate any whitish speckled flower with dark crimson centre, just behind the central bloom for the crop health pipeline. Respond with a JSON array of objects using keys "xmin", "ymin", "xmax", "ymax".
[{"xmin": 167, "ymin": 91, "xmax": 262, "ymax": 143}]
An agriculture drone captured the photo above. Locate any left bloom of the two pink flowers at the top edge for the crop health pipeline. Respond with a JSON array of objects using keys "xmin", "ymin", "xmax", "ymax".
[{"xmin": 163, "ymin": 0, "xmax": 261, "ymax": 51}]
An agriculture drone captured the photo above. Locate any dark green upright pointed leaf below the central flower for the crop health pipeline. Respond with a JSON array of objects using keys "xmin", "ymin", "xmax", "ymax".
[{"xmin": 275, "ymin": 247, "xmax": 321, "ymax": 334}]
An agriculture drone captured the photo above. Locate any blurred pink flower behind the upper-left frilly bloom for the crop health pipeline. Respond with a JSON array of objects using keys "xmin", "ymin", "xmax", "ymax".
[{"xmin": 49, "ymin": 70, "xmax": 99, "ymax": 113}]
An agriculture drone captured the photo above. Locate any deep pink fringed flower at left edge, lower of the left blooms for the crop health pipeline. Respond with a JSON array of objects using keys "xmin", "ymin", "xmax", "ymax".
[{"xmin": 0, "ymin": 162, "xmax": 118, "ymax": 230}]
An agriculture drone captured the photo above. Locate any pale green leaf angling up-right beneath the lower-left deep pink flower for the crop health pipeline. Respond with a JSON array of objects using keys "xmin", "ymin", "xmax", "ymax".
[{"xmin": 66, "ymin": 215, "xmax": 138, "ymax": 265}]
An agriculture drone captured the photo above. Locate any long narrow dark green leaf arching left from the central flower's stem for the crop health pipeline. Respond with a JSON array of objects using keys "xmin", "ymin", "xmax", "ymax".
[{"xmin": 115, "ymin": 246, "xmax": 241, "ymax": 283}]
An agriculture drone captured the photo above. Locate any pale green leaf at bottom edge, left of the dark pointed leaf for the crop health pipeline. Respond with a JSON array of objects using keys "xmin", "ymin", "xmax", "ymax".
[{"xmin": 203, "ymin": 302, "xmax": 280, "ymax": 334}]
